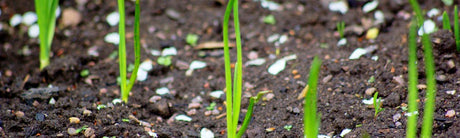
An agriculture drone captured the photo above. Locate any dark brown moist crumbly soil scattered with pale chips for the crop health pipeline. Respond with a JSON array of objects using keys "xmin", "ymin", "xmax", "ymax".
[{"xmin": 0, "ymin": 0, "xmax": 460, "ymax": 137}]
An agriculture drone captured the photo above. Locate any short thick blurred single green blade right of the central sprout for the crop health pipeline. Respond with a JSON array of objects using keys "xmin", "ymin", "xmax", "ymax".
[{"xmin": 303, "ymin": 56, "xmax": 322, "ymax": 138}]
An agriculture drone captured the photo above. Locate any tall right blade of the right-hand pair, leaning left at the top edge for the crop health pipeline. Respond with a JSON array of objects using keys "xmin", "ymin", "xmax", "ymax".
[{"xmin": 409, "ymin": 0, "xmax": 436, "ymax": 137}]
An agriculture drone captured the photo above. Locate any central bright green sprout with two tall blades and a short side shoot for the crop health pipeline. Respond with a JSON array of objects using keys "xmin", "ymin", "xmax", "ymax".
[{"xmin": 223, "ymin": 0, "xmax": 267, "ymax": 138}]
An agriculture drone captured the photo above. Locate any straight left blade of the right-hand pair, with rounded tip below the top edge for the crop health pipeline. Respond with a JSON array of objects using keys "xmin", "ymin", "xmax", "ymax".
[{"xmin": 406, "ymin": 21, "xmax": 418, "ymax": 138}]
